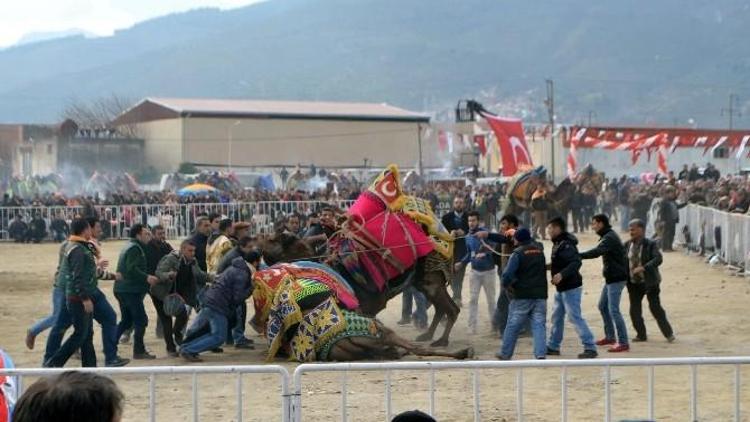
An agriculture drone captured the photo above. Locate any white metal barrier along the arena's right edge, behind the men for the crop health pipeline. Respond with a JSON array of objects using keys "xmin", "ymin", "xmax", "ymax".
[{"xmin": 678, "ymin": 205, "xmax": 750, "ymax": 271}]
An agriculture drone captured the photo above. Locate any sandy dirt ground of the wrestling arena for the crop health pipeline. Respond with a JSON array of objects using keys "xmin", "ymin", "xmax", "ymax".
[{"xmin": 0, "ymin": 235, "xmax": 750, "ymax": 421}]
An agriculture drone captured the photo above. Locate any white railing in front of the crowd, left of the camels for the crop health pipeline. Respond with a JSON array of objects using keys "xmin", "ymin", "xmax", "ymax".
[{"xmin": 0, "ymin": 201, "xmax": 353, "ymax": 240}]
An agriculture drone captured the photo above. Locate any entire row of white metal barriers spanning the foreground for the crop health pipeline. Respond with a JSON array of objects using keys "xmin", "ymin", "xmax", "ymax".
[{"xmin": 0, "ymin": 357, "xmax": 750, "ymax": 422}]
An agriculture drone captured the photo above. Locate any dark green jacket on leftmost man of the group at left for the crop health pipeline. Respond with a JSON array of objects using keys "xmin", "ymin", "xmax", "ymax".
[{"xmin": 57, "ymin": 241, "xmax": 97, "ymax": 301}]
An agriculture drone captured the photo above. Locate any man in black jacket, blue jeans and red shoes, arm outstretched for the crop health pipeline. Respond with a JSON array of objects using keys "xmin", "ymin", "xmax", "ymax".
[{"xmin": 580, "ymin": 214, "xmax": 630, "ymax": 353}]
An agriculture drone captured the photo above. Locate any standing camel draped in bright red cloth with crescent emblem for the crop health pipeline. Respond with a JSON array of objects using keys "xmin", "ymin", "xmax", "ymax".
[{"xmin": 261, "ymin": 165, "xmax": 460, "ymax": 347}]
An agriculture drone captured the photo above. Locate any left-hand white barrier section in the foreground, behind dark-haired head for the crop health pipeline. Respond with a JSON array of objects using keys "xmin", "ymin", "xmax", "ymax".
[{"xmin": 0, "ymin": 365, "xmax": 292, "ymax": 422}]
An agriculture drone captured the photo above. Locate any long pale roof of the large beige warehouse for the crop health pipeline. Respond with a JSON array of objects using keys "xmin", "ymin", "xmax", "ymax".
[{"xmin": 114, "ymin": 98, "xmax": 430, "ymax": 125}]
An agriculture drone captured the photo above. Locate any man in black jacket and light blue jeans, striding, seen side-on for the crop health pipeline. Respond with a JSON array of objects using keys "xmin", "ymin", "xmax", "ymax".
[{"xmin": 547, "ymin": 217, "xmax": 597, "ymax": 359}]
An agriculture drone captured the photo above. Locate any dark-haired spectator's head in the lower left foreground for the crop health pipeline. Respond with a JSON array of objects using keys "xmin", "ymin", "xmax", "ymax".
[{"xmin": 13, "ymin": 371, "xmax": 124, "ymax": 422}]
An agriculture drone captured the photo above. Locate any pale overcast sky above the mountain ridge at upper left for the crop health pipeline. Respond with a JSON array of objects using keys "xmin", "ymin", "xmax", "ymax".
[{"xmin": 0, "ymin": 0, "xmax": 259, "ymax": 47}]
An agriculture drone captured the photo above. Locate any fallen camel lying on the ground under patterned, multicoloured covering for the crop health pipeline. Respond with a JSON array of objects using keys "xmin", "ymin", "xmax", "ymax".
[{"xmin": 253, "ymin": 261, "xmax": 474, "ymax": 362}]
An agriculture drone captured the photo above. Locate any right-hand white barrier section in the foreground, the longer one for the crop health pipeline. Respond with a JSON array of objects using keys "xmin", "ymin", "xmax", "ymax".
[{"xmin": 291, "ymin": 357, "xmax": 750, "ymax": 422}]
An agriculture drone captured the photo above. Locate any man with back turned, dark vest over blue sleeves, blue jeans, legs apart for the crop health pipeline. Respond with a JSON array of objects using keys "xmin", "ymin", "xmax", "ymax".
[{"xmin": 495, "ymin": 227, "xmax": 547, "ymax": 360}]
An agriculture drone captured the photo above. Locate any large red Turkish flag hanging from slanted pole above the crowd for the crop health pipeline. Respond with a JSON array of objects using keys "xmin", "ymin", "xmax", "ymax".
[{"xmin": 482, "ymin": 114, "xmax": 534, "ymax": 177}]
